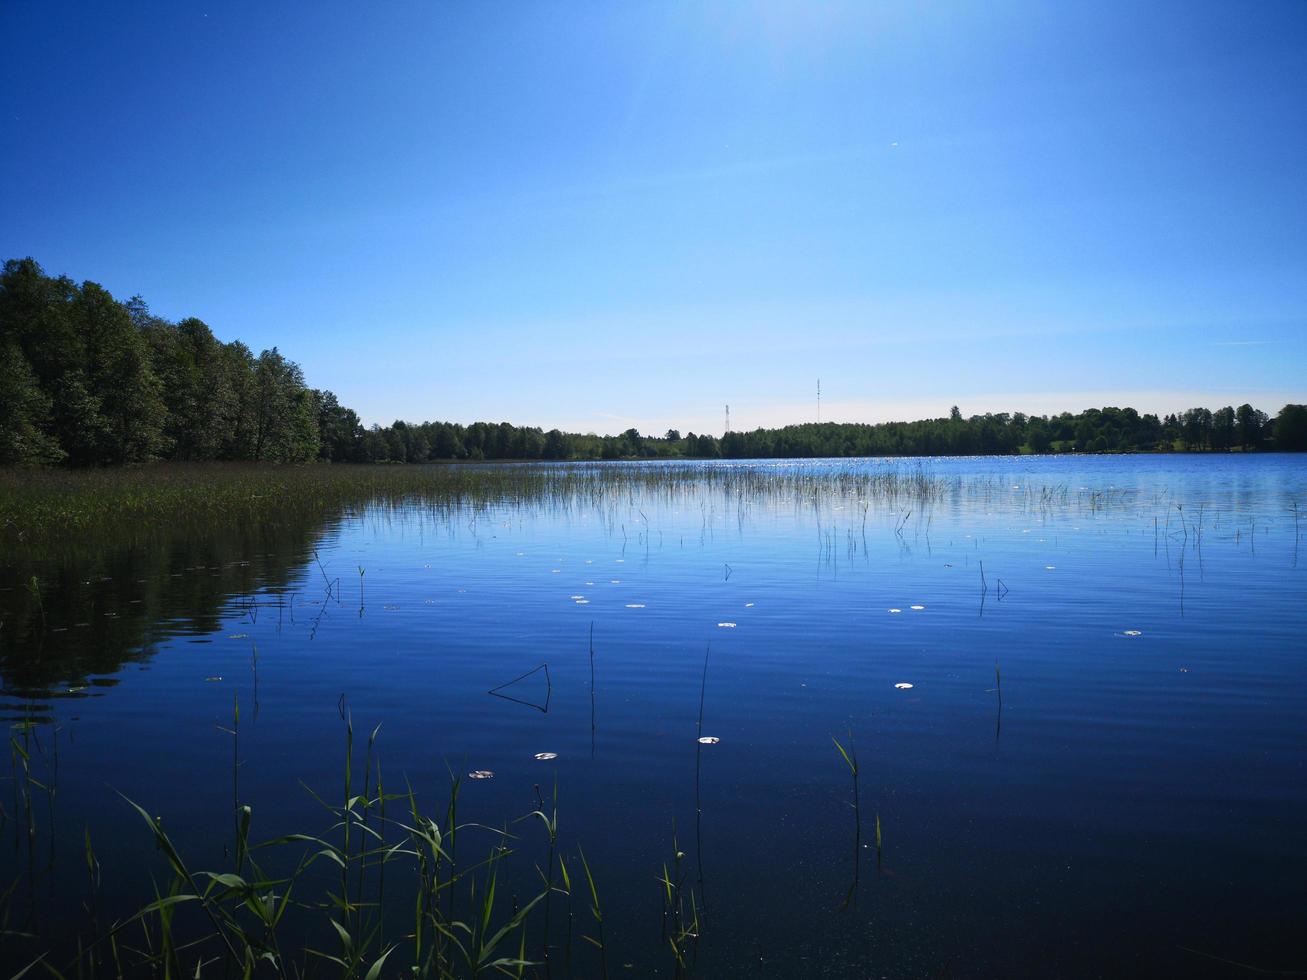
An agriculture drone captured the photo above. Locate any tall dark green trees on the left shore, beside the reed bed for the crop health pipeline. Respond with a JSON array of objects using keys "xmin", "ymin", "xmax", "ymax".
[{"xmin": 0, "ymin": 259, "xmax": 321, "ymax": 465}]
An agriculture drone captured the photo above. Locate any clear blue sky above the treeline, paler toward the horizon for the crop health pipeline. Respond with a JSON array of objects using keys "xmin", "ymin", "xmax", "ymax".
[{"xmin": 0, "ymin": 0, "xmax": 1307, "ymax": 433}]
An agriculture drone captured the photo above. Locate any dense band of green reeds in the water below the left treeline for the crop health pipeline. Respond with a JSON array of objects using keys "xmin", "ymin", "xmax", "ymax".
[{"xmin": 0, "ymin": 461, "xmax": 982, "ymax": 556}]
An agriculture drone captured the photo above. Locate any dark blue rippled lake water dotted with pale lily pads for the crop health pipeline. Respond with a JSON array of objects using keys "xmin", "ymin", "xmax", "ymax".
[{"xmin": 0, "ymin": 456, "xmax": 1307, "ymax": 977}]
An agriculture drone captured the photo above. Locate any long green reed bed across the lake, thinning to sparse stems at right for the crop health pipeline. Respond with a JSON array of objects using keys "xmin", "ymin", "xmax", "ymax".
[{"xmin": 0, "ymin": 460, "xmax": 1138, "ymax": 553}]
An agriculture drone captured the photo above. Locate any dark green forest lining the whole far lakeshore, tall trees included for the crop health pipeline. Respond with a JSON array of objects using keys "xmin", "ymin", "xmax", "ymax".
[{"xmin": 0, "ymin": 259, "xmax": 1307, "ymax": 466}]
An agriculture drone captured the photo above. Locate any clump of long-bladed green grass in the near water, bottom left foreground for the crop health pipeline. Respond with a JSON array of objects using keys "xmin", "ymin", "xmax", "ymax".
[{"xmin": 0, "ymin": 703, "xmax": 643, "ymax": 980}]
